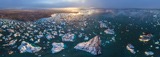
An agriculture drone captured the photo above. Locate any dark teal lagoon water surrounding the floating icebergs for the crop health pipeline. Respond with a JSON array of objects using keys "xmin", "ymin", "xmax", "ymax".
[{"xmin": 0, "ymin": 11, "xmax": 160, "ymax": 57}]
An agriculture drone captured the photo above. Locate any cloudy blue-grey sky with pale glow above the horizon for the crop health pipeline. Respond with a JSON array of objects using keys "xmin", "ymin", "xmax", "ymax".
[{"xmin": 0, "ymin": 0, "xmax": 160, "ymax": 8}]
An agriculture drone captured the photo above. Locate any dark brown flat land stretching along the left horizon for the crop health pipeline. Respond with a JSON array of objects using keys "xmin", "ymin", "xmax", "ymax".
[{"xmin": 0, "ymin": 9, "xmax": 77, "ymax": 21}]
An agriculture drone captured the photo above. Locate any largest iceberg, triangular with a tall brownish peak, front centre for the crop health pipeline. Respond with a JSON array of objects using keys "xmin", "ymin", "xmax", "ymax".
[{"xmin": 74, "ymin": 36, "xmax": 101, "ymax": 55}]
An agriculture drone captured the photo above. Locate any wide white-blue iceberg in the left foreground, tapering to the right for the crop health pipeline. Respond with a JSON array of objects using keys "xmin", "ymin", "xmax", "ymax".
[{"xmin": 18, "ymin": 41, "xmax": 42, "ymax": 53}]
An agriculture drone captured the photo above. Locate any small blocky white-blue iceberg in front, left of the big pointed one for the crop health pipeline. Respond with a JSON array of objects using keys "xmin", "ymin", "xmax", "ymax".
[{"xmin": 51, "ymin": 42, "xmax": 65, "ymax": 53}]
